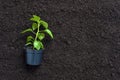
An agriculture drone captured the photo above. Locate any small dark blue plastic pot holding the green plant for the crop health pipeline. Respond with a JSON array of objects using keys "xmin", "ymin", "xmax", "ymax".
[{"xmin": 25, "ymin": 47, "xmax": 43, "ymax": 66}]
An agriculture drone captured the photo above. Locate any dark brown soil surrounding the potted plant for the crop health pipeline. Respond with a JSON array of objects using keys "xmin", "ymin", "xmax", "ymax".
[{"xmin": 0, "ymin": 0, "xmax": 120, "ymax": 80}]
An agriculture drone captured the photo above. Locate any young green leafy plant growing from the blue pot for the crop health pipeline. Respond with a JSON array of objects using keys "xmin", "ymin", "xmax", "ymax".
[{"xmin": 21, "ymin": 15, "xmax": 53, "ymax": 50}]
